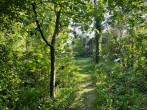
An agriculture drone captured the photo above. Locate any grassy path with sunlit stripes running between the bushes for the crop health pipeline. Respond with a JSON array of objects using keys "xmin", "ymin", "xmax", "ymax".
[{"xmin": 70, "ymin": 58, "xmax": 96, "ymax": 110}]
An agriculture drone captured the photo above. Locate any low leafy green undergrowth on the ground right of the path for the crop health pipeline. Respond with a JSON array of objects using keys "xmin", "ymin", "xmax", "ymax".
[{"xmin": 94, "ymin": 60, "xmax": 147, "ymax": 110}]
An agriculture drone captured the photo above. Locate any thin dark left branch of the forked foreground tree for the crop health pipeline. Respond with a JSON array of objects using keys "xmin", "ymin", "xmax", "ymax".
[{"xmin": 32, "ymin": 3, "xmax": 53, "ymax": 47}]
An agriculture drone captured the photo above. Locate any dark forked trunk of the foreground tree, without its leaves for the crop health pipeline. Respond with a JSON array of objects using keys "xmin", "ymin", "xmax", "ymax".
[{"xmin": 32, "ymin": 4, "xmax": 61, "ymax": 98}]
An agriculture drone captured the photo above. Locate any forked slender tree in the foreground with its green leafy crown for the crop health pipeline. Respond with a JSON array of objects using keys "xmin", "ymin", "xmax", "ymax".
[{"xmin": 32, "ymin": 0, "xmax": 94, "ymax": 98}]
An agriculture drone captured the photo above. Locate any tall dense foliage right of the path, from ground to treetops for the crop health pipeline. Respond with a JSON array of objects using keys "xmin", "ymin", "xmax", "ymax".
[{"xmin": 95, "ymin": 0, "xmax": 147, "ymax": 110}]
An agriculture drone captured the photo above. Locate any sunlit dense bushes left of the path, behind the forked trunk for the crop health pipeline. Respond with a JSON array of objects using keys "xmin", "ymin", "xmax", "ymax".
[{"xmin": 0, "ymin": 21, "xmax": 79, "ymax": 110}]
